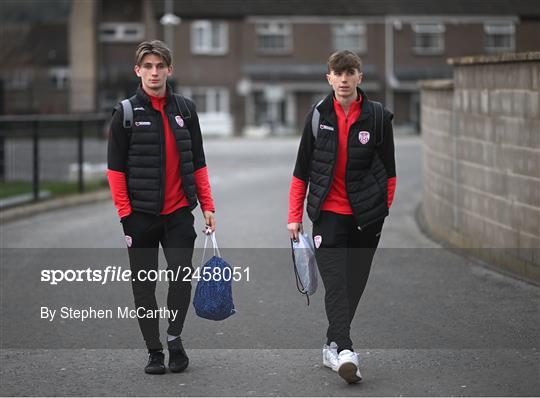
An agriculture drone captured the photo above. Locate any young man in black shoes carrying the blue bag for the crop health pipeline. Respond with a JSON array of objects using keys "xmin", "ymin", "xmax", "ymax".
[{"xmin": 107, "ymin": 40, "xmax": 215, "ymax": 374}]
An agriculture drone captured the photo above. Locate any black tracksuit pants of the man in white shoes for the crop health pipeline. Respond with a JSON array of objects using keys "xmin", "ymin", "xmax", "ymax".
[{"xmin": 313, "ymin": 211, "xmax": 384, "ymax": 351}]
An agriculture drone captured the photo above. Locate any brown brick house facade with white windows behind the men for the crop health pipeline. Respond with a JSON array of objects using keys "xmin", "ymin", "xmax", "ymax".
[{"xmin": 2, "ymin": 0, "xmax": 540, "ymax": 135}]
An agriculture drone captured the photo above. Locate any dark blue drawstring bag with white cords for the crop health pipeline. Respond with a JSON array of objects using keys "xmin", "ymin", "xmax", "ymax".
[{"xmin": 193, "ymin": 232, "xmax": 236, "ymax": 321}]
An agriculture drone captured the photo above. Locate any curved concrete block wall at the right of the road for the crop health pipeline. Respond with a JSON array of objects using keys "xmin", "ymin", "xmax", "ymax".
[{"xmin": 421, "ymin": 52, "xmax": 540, "ymax": 282}]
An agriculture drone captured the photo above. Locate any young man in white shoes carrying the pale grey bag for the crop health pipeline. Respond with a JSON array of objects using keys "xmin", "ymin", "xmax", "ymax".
[{"xmin": 287, "ymin": 51, "xmax": 396, "ymax": 383}]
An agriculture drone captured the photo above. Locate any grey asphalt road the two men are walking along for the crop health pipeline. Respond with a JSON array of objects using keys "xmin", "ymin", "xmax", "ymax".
[{"xmin": 0, "ymin": 137, "xmax": 540, "ymax": 396}]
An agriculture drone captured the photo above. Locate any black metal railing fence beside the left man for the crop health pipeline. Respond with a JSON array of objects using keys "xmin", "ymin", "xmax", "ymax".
[{"xmin": 0, "ymin": 114, "xmax": 110, "ymax": 201}]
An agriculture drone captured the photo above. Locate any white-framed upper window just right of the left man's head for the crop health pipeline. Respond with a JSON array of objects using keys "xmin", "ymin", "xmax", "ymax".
[{"xmin": 191, "ymin": 21, "xmax": 229, "ymax": 55}]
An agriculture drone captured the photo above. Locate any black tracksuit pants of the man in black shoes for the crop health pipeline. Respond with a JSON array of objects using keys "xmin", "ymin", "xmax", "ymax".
[{"xmin": 122, "ymin": 207, "xmax": 197, "ymax": 351}]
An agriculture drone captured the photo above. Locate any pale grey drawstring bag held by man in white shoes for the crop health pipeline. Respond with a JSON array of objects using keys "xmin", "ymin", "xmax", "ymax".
[{"xmin": 291, "ymin": 233, "xmax": 317, "ymax": 305}]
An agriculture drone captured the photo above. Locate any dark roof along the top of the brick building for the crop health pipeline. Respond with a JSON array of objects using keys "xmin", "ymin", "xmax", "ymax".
[{"xmin": 154, "ymin": 0, "xmax": 540, "ymax": 19}]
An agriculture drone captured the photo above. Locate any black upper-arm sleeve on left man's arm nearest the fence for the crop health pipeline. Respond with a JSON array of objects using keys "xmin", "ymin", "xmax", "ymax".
[{"xmin": 107, "ymin": 104, "xmax": 129, "ymax": 172}]
